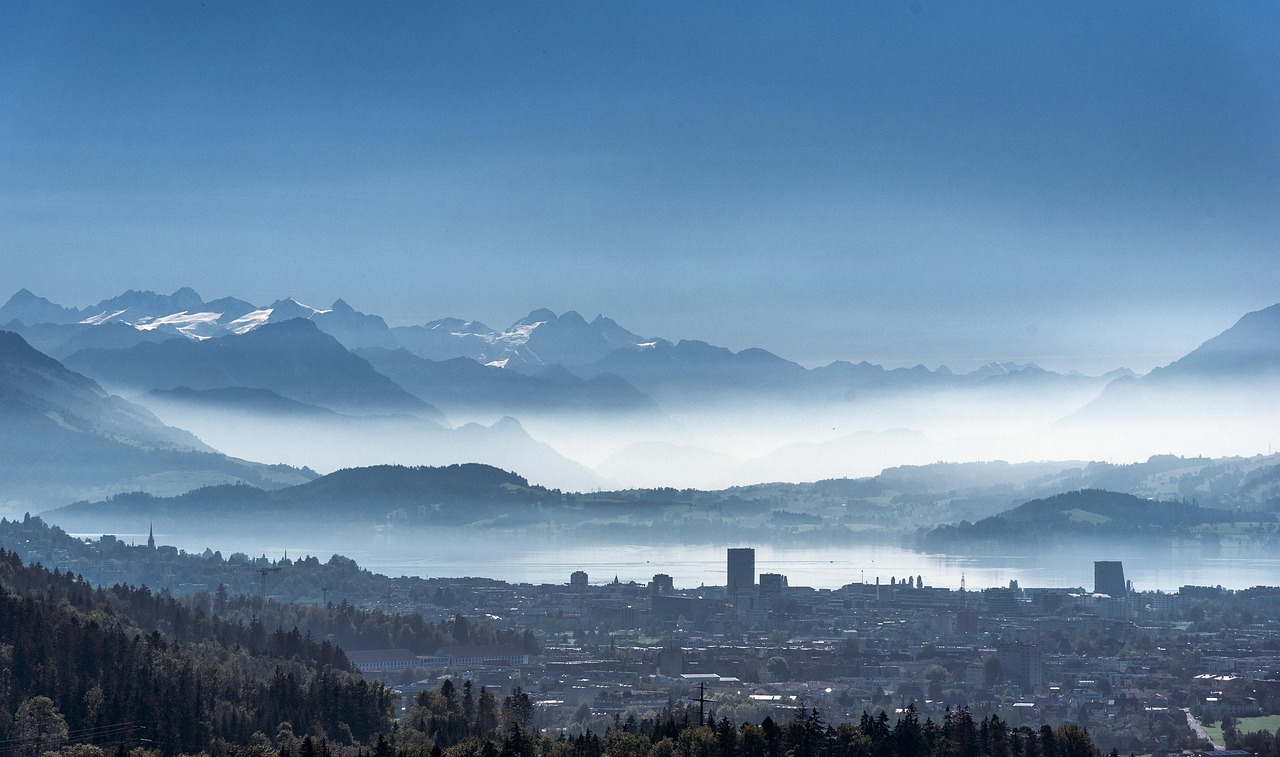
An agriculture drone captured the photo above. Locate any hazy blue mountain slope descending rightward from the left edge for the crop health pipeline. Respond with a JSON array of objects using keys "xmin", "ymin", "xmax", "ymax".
[{"xmin": 0, "ymin": 332, "xmax": 307, "ymax": 510}]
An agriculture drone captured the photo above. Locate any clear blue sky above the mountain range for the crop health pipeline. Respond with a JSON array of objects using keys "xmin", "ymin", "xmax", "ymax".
[{"xmin": 0, "ymin": 0, "xmax": 1280, "ymax": 373}]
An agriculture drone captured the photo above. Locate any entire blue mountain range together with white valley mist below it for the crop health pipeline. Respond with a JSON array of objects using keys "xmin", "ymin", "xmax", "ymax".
[{"xmin": 0, "ymin": 288, "xmax": 1280, "ymax": 489}]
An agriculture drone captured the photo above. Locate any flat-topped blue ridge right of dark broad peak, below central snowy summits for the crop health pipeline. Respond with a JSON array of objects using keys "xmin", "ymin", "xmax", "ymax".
[{"xmin": 356, "ymin": 348, "xmax": 657, "ymax": 415}]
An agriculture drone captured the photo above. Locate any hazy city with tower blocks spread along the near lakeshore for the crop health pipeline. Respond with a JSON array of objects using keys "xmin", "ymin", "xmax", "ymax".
[{"xmin": 0, "ymin": 519, "xmax": 1280, "ymax": 753}]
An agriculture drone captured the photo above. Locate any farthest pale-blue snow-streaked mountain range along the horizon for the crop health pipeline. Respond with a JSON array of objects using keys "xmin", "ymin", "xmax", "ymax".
[{"xmin": 0, "ymin": 288, "xmax": 1126, "ymax": 410}]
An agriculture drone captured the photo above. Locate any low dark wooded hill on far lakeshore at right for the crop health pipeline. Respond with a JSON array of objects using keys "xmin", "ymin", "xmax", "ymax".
[{"xmin": 919, "ymin": 489, "xmax": 1276, "ymax": 549}]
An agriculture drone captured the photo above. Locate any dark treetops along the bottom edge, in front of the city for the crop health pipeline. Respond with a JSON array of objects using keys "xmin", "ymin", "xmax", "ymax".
[{"xmin": 385, "ymin": 681, "xmax": 1117, "ymax": 757}]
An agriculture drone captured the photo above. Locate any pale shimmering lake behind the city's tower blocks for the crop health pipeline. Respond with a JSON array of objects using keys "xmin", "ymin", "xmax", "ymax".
[{"xmin": 112, "ymin": 532, "xmax": 1280, "ymax": 592}]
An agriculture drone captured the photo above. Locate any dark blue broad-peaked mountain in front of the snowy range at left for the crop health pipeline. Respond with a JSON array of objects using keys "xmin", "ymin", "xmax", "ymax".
[{"xmin": 67, "ymin": 319, "xmax": 444, "ymax": 421}]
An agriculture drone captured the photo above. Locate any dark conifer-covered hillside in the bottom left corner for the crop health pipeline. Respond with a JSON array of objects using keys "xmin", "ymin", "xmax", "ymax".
[{"xmin": 0, "ymin": 549, "xmax": 392, "ymax": 754}]
